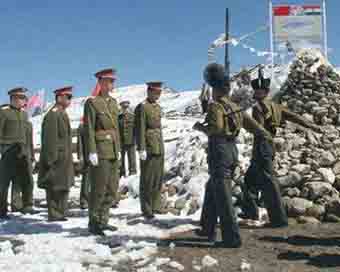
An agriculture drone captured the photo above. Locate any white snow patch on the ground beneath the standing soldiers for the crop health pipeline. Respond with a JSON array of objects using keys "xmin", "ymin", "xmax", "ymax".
[{"xmin": 0, "ymin": 176, "xmax": 198, "ymax": 272}]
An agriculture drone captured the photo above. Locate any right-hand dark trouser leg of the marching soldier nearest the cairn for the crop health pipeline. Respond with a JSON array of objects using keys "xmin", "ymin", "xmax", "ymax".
[{"xmin": 261, "ymin": 141, "xmax": 288, "ymax": 225}]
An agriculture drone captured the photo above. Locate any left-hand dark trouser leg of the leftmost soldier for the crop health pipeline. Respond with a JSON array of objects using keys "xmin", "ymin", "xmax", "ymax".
[{"xmin": 0, "ymin": 152, "xmax": 16, "ymax": 216}]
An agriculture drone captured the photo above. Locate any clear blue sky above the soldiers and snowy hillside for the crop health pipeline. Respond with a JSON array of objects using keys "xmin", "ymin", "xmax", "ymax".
[{"xmin": 0, "ymin": 0, "xmax": 340, "ymax": 103}]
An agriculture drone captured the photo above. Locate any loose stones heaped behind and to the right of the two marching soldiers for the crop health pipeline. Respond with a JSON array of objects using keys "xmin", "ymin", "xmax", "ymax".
[{"xmin": 160, "ymin": 50, "xmax": 340, "ymax": 223}]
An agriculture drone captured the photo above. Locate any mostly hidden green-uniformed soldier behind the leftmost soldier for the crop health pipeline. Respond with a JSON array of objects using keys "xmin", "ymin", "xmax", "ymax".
[{"xmin": 11, "ymin": 118, "xmax": 38, "ymax": 214}]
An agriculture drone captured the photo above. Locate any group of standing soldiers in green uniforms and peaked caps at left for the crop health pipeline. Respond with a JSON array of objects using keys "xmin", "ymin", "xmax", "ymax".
[{"xmin": 0, "ymin": 69, "xmax": 164, "ymax": 235}]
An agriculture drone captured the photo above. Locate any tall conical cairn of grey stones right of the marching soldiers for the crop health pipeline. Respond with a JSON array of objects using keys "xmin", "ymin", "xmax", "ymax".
[{"xmin": 275, "ymin": 50, "xmax": 340, "ymax": 223}]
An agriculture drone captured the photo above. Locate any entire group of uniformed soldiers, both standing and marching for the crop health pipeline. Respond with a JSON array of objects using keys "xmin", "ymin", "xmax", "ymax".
[{"xmin": 0, "ymin": 64, "xmax": 322, "ymax": 247}]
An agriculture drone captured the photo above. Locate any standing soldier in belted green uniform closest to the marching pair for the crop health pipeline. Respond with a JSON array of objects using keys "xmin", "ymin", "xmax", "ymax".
[{"xmin": 135, "ymin": 82, "xmax": 164, "ymax": 219}]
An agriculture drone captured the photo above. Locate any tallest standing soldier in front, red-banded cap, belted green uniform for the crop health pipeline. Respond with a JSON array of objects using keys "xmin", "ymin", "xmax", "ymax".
[{"xmin": 84, "ymin": 69, "xmax": 121, "ymax": 235}]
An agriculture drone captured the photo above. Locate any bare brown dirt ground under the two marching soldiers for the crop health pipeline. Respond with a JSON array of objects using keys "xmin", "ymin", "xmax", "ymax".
[{"xmin": 155, "ymin": 221, "xmax": 340, "ymax": 272}]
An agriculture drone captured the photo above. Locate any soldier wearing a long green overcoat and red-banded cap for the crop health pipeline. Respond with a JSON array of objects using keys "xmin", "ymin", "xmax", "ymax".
[{"xmin": 38, "ymin": 87, "xmax": 74, "ymax": 221}]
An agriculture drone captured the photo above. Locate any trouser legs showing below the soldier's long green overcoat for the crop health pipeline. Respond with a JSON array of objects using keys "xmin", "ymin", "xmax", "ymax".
[{"xmin": 46, "ymin": 188, "xmax": 69, "ymax": 220}]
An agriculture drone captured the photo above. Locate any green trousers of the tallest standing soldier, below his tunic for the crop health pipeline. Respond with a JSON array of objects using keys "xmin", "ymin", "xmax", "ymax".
[{"xmin": 89, "ymin": 159, "xmax": 118, "ymax": 226}]
